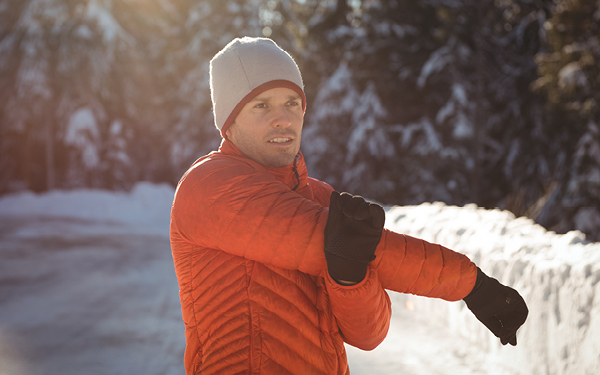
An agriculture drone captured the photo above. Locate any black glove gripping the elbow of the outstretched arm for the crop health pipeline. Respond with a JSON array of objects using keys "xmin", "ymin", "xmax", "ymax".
[{"xmin": 325, "ymin": 191, "xmax": 385, "ymax": 283}]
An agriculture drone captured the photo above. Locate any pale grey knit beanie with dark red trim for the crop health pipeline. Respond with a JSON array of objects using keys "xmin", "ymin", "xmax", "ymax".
[{"xmin": 210, "ymin": 37, "xmax": 306, "ymax": 138}]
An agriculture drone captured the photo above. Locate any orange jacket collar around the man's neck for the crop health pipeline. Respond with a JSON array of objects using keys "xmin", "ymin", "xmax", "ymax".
[{"xmin": 219, "ymin": 138, "xmax": 312, "ymax": 198}]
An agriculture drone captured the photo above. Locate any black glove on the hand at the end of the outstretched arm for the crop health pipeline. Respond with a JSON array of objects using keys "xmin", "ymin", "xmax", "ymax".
[{"xmin": 464, "ymin": 267, "xmax": 529, "ymax": 346}]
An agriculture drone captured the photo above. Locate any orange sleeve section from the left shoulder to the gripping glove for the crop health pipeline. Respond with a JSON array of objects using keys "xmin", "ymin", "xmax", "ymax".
[{"xmin": 171, "ymin": 158, "xmax": 328, "ymax": 276}]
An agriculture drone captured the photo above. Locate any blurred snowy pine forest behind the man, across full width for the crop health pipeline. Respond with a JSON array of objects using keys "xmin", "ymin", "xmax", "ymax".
[{"xmin": 0, "ymin": 0, "xmax": 600, "ymax": 240}]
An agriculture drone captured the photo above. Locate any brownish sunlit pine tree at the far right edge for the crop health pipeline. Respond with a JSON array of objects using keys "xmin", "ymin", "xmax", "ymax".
[{"xmin": 533, "ymin": 0, "xmax": 600, "ymax": 240}]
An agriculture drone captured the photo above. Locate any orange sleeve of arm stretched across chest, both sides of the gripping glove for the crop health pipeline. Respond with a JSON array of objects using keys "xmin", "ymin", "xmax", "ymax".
[{"xmin": 171, "ymin": 158, "xmax": 477, "ymax": 300}]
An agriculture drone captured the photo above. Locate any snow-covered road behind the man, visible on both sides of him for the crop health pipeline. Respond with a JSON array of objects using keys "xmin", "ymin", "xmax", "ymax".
[{"xmin": 0, "ymin": 217, "xmax": 506, "ymax": 375}]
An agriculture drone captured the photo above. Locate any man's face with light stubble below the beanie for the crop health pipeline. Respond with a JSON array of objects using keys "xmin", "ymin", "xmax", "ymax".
[{"xmin": 226, "ymin": 87, "xmax": 304, "ymax": 168}]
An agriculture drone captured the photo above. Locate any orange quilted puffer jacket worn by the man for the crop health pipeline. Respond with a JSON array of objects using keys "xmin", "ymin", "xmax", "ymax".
[{"xmin": 171, "ymin": 140, "xmax": 476, "ymax": 375}]
